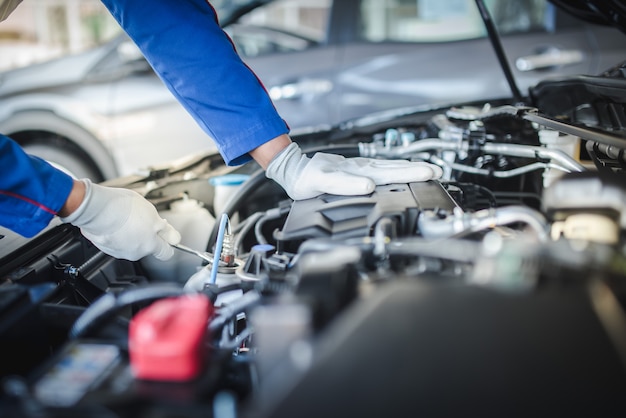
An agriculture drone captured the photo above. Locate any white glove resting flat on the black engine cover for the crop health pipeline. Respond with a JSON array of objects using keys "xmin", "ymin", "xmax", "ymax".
[{"xmin": 265, "ymin": 142, "xmax": 443, "ymax": 200}]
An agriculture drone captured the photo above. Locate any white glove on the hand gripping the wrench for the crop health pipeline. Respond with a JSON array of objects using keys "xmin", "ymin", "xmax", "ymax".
[{"xmin": 61, "ymin": 179, "xmax": 180, "ymax": 261}]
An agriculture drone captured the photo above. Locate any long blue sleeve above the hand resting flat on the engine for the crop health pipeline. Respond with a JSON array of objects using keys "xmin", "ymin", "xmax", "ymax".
[{"xmin": 102, "ymin": 0, "xmax": 289, "ymax": 165}]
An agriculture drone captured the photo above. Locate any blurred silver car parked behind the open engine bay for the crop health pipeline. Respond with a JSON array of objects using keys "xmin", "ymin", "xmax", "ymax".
[{"xmin": 0, "ymin": 0, "xmax": 626, "ymax": 181}]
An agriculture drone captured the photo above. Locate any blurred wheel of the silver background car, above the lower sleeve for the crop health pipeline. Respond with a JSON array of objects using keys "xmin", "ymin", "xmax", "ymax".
[{"xmin": 22, "ymin": 143, "xmax": 104, "ymax": 183}]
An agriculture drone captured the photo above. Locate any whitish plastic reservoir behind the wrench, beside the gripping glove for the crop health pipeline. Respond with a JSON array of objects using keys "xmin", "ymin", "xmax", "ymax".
[{"xmin": 141, "ymin": 199, "xmax": 215, "ymax": 283}]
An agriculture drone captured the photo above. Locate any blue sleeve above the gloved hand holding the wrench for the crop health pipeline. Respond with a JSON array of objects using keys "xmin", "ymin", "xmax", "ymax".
[{"xmin": 0, "ymin": 135, "xmax": 73, "ymax": 237}]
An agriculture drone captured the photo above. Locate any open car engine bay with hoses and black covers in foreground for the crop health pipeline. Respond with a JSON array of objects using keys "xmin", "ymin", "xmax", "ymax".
[{"xmin": 0, "ymin": 94, "xmax": 626, "ymax": 417}]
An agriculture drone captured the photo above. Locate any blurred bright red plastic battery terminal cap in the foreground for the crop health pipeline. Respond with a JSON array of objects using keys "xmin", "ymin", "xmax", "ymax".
[{"xmin": 128, "ymin": 294, "xmax": 213, "ymax": 381}]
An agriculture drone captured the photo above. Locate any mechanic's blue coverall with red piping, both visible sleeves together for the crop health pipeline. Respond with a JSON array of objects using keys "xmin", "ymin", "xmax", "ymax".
[{"xmin": 0, "ymin": 0, "xmax": 289, "ymax": 237}]
